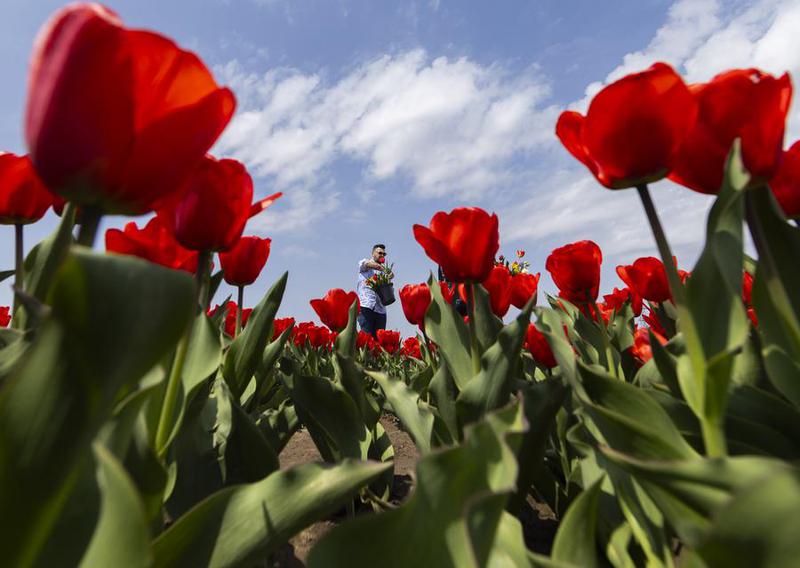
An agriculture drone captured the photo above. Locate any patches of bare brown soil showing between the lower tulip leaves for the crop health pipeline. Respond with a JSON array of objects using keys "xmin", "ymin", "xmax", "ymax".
[{"xmin": 269, "ymin": 414, "xmax": 558, "ymax": 568}]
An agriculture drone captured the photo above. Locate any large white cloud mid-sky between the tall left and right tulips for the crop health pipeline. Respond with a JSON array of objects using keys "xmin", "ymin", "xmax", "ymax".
[{"xmin": 216, "ymin": 50, "xmax": 557, "ymax": 222}]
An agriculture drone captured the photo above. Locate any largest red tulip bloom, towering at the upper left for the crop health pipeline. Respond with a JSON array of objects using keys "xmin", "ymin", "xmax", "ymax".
[{"xmin": 25, "ymin": 4, "xmax": 236, "ymax": 215}]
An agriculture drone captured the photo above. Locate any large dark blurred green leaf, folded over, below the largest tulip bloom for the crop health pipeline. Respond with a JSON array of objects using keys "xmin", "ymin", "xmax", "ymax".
[{"xmin": 0, "ymin": 248, "xmax": 194, "ymax": 566}]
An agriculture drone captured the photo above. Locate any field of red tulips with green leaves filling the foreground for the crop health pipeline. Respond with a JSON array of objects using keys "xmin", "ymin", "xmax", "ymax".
[{"xmin": 0, "ymin": 4, "xmax": 800, "ymax": 568}]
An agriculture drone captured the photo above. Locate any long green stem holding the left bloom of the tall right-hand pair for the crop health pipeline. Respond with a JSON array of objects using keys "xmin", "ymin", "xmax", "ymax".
[{"xmin": 636, "ymin": 185, "xmax": 728, "ymax": 457}]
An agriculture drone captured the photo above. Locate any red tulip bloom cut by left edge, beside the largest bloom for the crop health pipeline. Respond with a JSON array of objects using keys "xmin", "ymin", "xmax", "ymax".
[{"xmin": 0, "ymin": 152, "xmax": 55, "ymax": 225}]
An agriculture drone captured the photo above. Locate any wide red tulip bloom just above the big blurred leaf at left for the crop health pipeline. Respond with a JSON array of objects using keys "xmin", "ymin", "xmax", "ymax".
[{"xmin": 106, "ymin": 217, "xmax": 197, "ymax": 273}]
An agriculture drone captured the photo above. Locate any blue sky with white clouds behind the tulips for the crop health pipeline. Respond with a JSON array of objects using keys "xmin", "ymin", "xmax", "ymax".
[{"xmin": 0, "ymin": 0, "xmax": 800, "ymax": 332}]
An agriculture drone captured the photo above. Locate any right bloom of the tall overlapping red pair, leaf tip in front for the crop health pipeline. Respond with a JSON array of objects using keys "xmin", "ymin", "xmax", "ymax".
[{"xmin": 669, "ymin": 69, "xmax": 792, "ymax": 193}]
